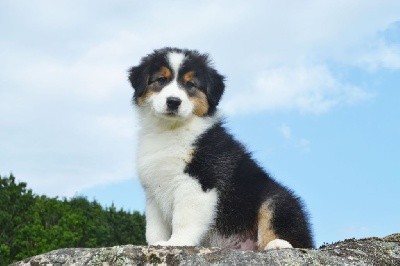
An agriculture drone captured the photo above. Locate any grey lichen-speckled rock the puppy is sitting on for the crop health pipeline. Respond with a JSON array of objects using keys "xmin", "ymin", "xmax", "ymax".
[{"xmin": 11, "ymin": 234, "xmax": 400, "ymax": 266}]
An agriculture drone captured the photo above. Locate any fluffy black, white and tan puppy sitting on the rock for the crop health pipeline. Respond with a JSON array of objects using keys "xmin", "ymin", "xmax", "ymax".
[{"xmin": 129, "ymin": 48, "xmax": 313, "ymax": 250}]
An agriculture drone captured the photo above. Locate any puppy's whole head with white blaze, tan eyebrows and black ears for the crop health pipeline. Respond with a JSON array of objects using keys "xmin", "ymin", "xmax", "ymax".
[{"xmin": 129, "ymin": 48, "xmax": 225, "ymax": 120}]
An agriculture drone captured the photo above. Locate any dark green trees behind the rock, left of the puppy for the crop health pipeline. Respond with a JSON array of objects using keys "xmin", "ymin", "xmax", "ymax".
[{"xmin": 0, "ymin": 174, "xmax": 146, "ymax": 265}]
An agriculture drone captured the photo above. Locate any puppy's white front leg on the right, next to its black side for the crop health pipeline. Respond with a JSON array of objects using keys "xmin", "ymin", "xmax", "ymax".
[{"xmin": 156, "ymin": 177, "xmax": 218, "ymax": 246}]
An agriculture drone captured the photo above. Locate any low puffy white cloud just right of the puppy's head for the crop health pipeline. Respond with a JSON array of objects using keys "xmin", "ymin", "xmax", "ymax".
[{"xmin": 223, "ymin": 65, "xmax": 373, "ymax": 114}]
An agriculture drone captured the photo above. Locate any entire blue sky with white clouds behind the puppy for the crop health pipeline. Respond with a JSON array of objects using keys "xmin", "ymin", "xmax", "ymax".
[{"xmin": 0, "ymin": 0, "xmax": 400, "ymax": 245}]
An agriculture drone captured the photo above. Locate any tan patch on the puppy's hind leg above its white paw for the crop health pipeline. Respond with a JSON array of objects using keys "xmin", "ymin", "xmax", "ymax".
[{"xmin": 257, "ymin": 200, "xmax": 278, "ymax": 250}]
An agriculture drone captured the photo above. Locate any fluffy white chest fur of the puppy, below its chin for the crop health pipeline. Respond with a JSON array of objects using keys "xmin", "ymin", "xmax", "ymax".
[{"xmin": 137, "ymin": 118, "xmax": 213, "ymax": 219}]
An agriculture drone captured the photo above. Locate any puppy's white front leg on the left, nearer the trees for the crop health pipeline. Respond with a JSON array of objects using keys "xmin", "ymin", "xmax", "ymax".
[{"xmin": 146, "ymin": 199, "xmax": 171, "ymax": 245}]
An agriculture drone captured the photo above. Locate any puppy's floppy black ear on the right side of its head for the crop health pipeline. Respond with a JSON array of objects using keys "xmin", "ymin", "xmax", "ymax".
[{"xmin": 207, "ymin": 67, "xmax": 225, "ymax": 114}]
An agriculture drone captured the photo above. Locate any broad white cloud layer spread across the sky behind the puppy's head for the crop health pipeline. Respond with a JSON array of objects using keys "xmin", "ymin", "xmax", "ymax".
[{"xmin": 0, "ymin": 0, "xmax": 400, "ymax": 195}]
